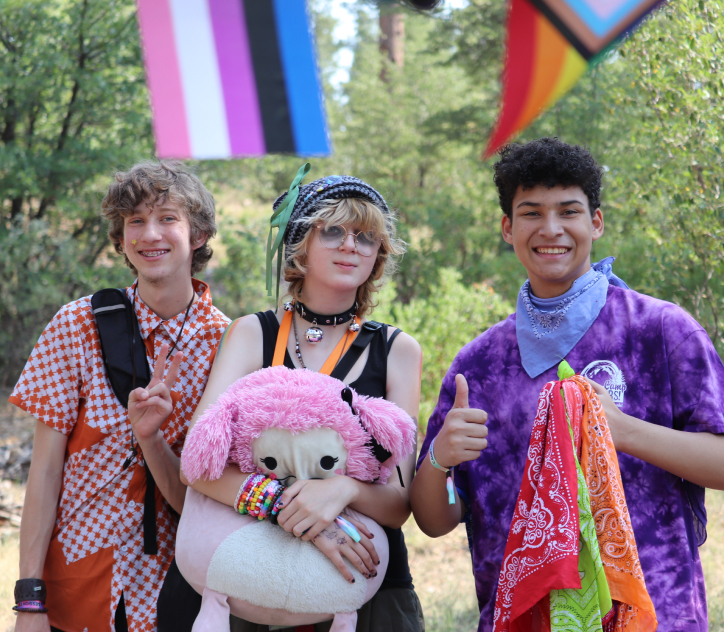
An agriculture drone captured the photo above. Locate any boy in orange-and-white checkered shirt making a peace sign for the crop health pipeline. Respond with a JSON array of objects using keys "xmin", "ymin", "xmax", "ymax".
[{"xmin": 10, "ymin": 162, "xmax": 229, "ymax": 632}]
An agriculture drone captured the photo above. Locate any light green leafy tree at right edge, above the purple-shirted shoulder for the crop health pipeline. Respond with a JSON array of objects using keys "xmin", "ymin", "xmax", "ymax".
[{"xmin": 608, "ymin": 0, "xmax": 724, "ymax": 353}]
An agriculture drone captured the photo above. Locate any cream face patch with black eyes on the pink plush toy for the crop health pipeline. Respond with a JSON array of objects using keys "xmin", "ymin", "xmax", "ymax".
[{"xmin": 251, "ymin": 428, "xmax": 347, "ymax": 486}]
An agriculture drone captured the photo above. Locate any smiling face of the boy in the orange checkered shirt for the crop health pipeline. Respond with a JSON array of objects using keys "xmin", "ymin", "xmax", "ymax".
[{"xmin": 122, "ymin": 199, "xmax": 205, "ymax": 294}]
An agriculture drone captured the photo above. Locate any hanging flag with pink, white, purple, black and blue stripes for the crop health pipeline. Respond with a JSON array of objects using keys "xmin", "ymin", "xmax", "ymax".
[{"xmin": 137, "ymin": 0, "xmax": 330, "ymax": 159}]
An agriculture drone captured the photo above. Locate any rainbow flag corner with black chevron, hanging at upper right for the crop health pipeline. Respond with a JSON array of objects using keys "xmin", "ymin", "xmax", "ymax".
[{"xmin": 484, "ymin": 0, "xmax": 663, "ymax": 158}]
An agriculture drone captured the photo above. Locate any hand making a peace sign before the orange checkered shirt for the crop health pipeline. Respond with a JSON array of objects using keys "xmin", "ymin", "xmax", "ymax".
[{"xmin": 128, "ymin": 344, "xmax": 184, "ymax": 443}]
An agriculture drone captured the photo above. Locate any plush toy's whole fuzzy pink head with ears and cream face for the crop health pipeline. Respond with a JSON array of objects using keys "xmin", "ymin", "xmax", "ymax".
[{"xmin": 181, "ymin": 366, "xmax": 417, "ymax": 484}]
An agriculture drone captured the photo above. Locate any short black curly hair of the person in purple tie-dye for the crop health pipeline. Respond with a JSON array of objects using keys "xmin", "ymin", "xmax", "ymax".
[{"xmin": 493, "ymin": 138, "xmax": 603, "ymax": 219}]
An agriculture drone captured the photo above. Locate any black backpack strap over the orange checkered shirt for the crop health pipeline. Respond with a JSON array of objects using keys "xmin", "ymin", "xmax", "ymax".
[{"xmin": 91, "ymin": 288, "xmax": 158, "ymax": 555}]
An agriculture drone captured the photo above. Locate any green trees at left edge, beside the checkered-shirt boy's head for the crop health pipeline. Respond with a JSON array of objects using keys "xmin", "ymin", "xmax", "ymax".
[{"xmin": 0, "ymin": 0, "xmax": 151, "ymax": 382}]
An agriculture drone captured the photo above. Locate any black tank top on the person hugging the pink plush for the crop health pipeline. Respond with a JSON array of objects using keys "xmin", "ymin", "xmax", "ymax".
[{"xmin": 256, "ymin": 310, "xmax": 413, "ymax": 590}]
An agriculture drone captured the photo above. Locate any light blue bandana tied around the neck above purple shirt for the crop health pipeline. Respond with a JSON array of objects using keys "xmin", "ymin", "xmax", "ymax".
[{"xmin": 515, "ymin": 257, "xmax": 628, "ymax": 377}]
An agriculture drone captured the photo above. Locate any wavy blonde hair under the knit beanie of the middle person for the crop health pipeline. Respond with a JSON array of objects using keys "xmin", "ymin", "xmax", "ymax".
[{"xmin": 282, "ymin": 198, "xmax": 406, "ymax": 316}]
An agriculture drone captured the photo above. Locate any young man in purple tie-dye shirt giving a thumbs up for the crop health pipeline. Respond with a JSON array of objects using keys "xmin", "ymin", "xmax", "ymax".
[{"xmin": 410, "ymin": 138, "xmax": 724, "ymax": 632}]
